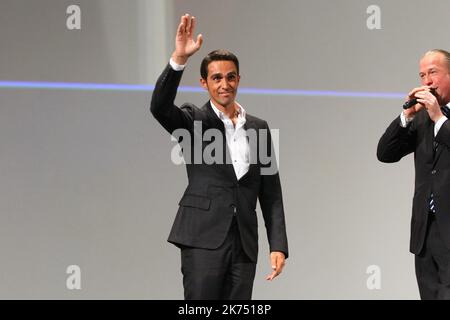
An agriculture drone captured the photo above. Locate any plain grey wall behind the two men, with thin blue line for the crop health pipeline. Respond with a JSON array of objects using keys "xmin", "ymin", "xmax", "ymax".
[{"xmin": 0, "ymin": 0, "xmax": 450, "ymax": 299}]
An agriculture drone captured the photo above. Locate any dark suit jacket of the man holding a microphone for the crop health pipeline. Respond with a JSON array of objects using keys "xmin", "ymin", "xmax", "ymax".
[{"xmin": 377, "ymin": 110, "xmax": 450, "ymax": 254}]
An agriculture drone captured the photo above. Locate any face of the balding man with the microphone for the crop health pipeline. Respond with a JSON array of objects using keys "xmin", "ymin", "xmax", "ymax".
[{"xmin": 419, "ymin": 52, "xmax": 450, "ymax": 105}]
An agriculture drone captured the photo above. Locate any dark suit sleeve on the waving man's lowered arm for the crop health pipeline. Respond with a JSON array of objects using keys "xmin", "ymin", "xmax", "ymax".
[{"xmin": 259, "ymin": 122, "xmax": 289, "ymax": 258}]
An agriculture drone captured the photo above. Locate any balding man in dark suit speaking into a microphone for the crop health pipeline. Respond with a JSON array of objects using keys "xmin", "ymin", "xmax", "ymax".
[{"xmin": 377, "ymin": 49, "xmax": 450, "ymax": 299}]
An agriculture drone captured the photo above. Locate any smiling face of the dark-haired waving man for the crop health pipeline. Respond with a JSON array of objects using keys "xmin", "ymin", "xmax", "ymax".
[{"xmin": 200, "ymin": 60, "xmax": 240, "ymax": 108}]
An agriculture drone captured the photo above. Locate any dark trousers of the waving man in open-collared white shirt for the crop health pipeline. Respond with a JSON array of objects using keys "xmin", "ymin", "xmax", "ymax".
[{"xmin": 181, "ymin": 220, "xmax": 256, "ymax": 300}]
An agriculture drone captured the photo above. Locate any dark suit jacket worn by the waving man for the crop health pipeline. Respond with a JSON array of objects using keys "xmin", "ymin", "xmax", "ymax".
[{"xmin": 150, "ymin": 65, "xmax": 288, "ymax": 262}]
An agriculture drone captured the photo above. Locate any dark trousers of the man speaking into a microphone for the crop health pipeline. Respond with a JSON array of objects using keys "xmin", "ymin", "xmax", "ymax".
[{"xmin": 415, "ymin": 214, "xmax": 450, "ymax": 300}]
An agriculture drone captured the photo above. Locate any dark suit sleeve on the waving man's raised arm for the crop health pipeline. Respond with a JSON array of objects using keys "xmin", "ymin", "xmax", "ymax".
[{"xmin": 150, "ymin": 64, "xmax": 193, "ymax": 134}]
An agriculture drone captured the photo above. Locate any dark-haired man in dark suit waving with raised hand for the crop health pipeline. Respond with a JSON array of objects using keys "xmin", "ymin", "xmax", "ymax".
[{"xmin": 150, "ymin": 15, "xmax": 288, "ymax": 299}]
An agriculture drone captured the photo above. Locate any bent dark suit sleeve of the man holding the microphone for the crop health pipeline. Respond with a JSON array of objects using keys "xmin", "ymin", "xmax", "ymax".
[{"xmin": 377, "ymin": 117, "xmax": 417, "ymax": 163}]
